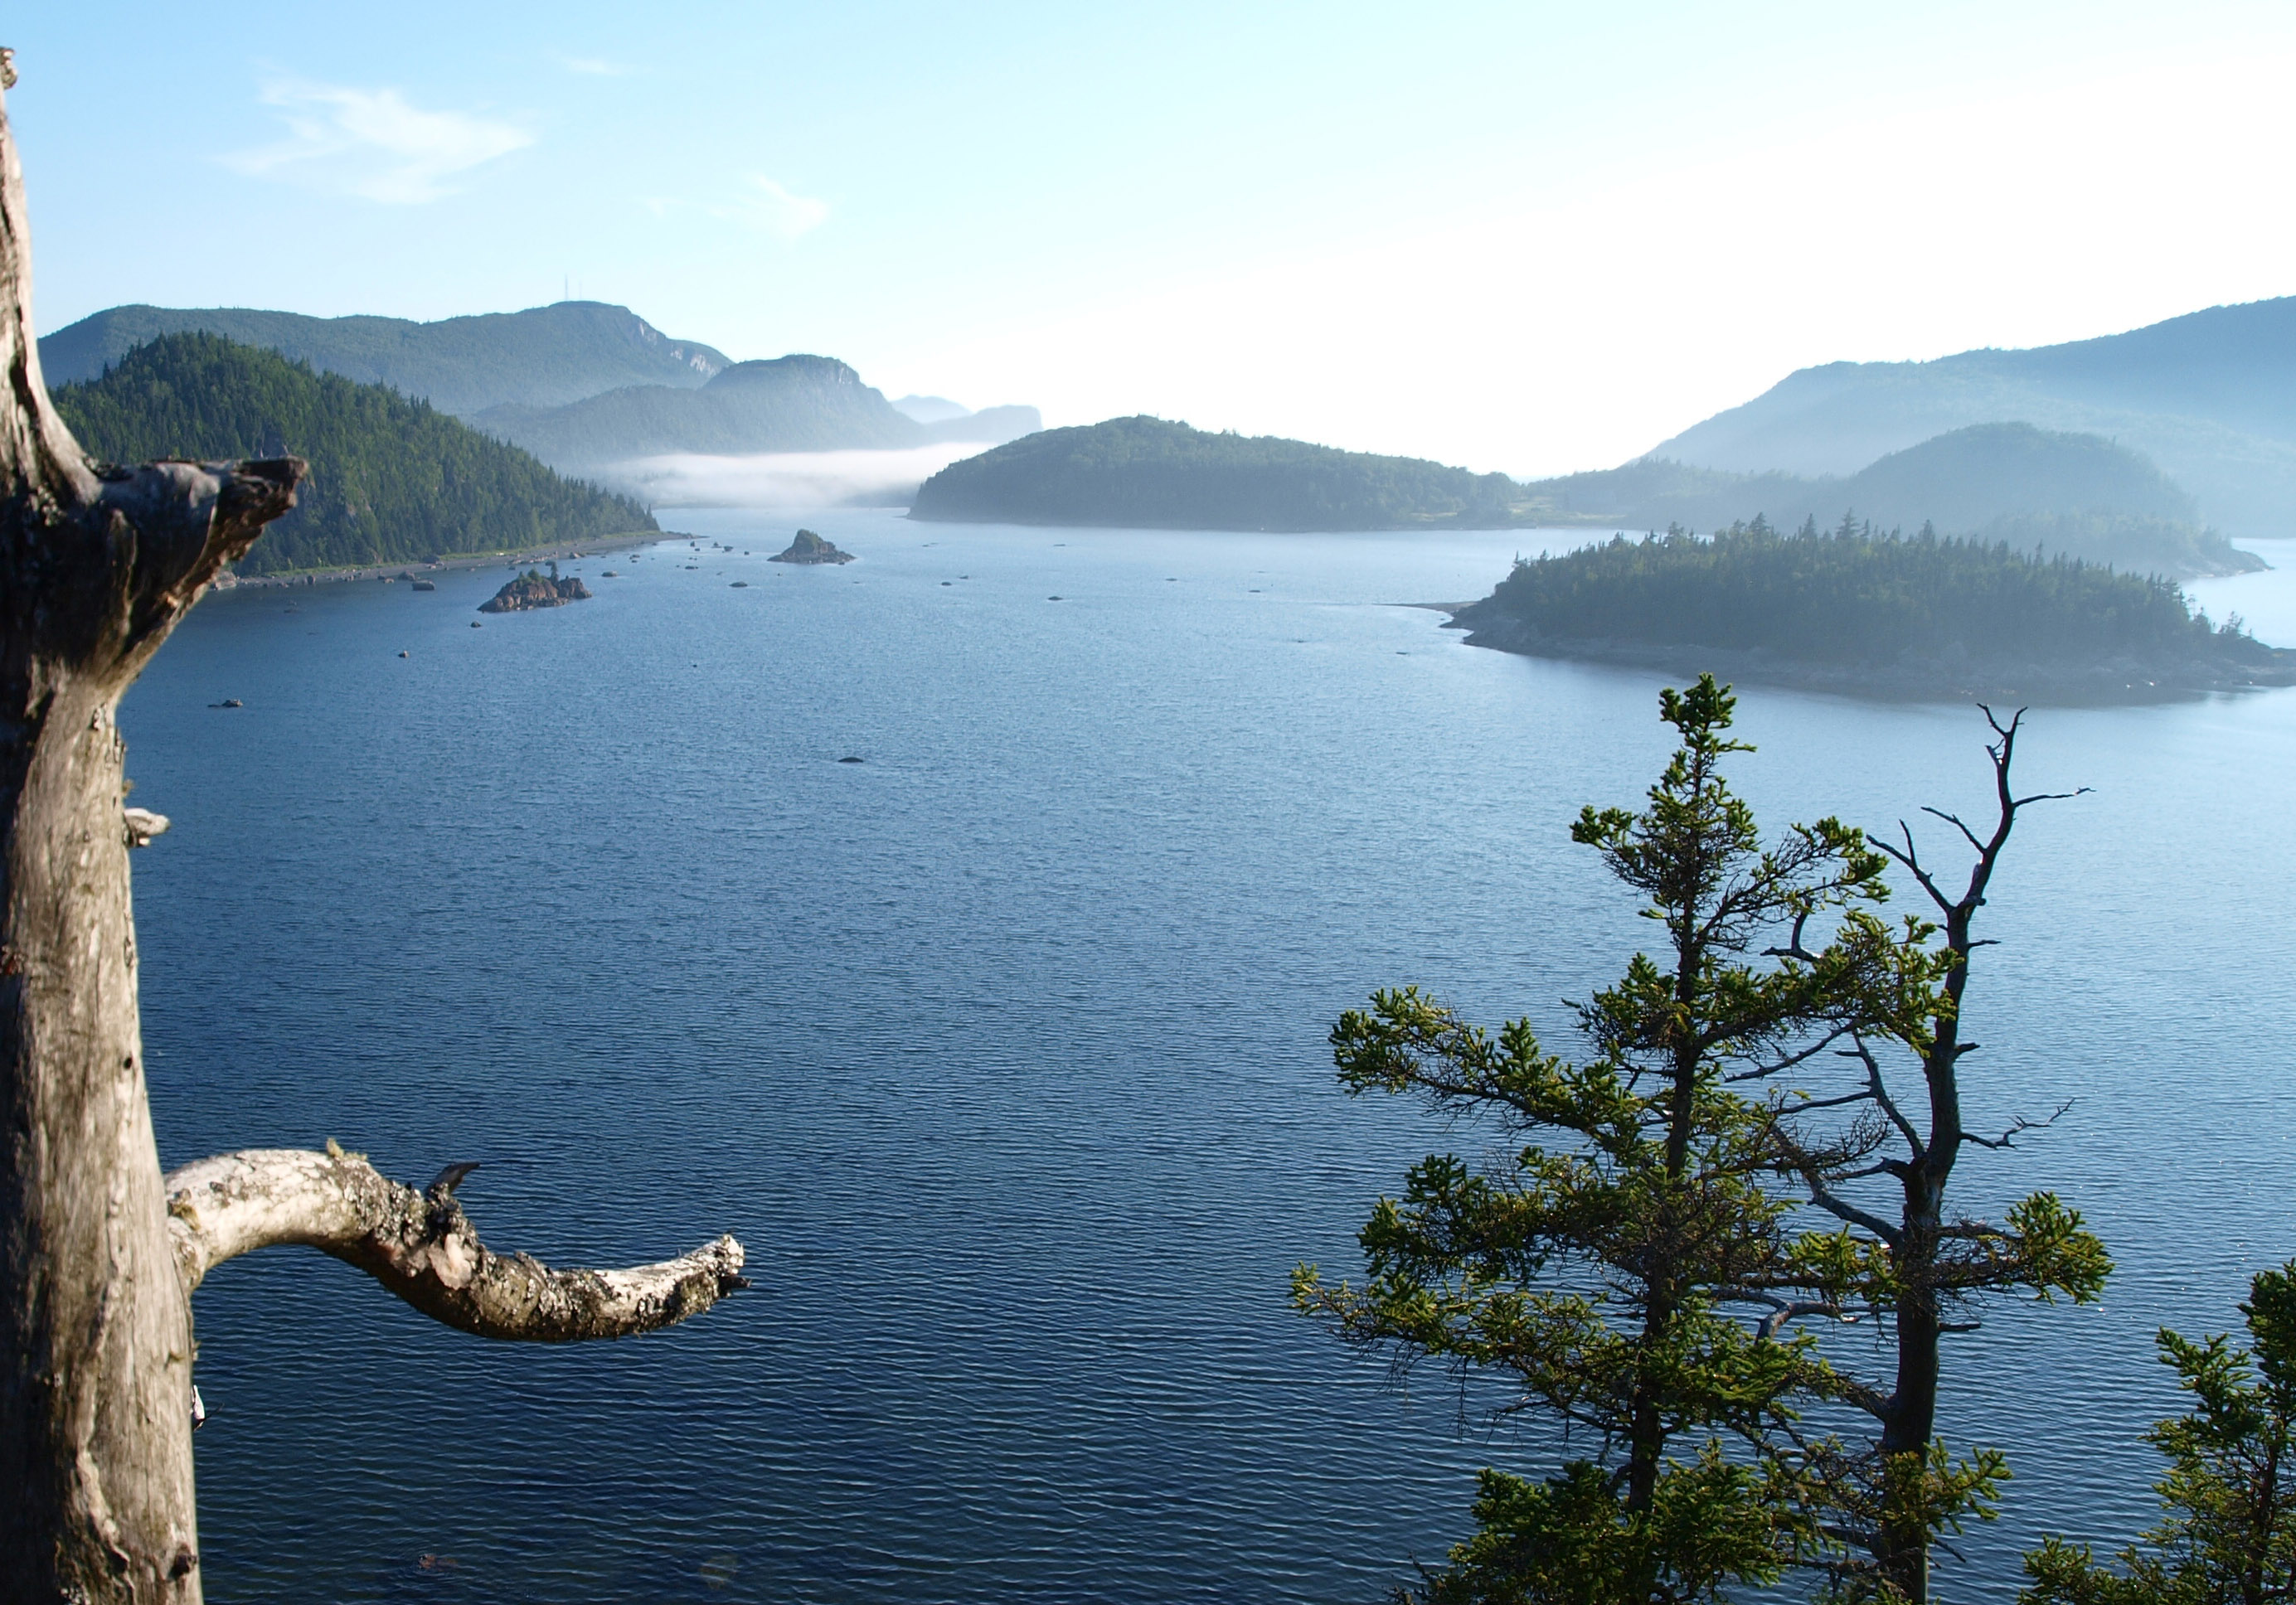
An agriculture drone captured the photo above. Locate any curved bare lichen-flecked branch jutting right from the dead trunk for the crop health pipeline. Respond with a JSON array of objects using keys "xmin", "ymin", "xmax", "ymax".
[{"xmin": 167, "ymin": 1143, "xmax": 749, "ymax": 1343}]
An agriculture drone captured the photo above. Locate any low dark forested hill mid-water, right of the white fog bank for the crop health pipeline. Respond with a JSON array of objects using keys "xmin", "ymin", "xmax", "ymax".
[{"xmin": 911, "ymin": 418, "xmax": 1531, "ymax": 531}]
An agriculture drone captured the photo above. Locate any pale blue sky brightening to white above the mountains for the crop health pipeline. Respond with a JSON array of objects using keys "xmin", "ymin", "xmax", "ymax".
[{"xmin": 13, "ymin": 0, "xmax": 2296, "ymax": 475}]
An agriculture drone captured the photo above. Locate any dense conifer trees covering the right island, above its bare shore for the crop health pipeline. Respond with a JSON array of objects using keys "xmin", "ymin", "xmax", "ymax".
[{"xmin": 1460, "ymin": 514, "xmax": 2275, "ymax": 666}]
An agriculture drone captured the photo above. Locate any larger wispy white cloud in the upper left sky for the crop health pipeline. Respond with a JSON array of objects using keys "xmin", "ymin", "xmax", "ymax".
[{"xmin": 223, "ymin": 78, "xmax": 535, "ymax": 206}]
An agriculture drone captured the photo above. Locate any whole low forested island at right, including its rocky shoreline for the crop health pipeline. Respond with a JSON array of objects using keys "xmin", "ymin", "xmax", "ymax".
[{"xmin": 1451, "ymin": 516, "xmax": 2296, "ymax": 701}]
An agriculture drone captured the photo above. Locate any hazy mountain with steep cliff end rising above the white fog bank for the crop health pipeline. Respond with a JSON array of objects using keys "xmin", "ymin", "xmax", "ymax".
[{"xmin": 471, "ymin": 367, "xmax": 1040, "ymax": 471}]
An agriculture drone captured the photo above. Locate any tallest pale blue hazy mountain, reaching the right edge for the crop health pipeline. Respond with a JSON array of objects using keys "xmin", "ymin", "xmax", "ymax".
[{"xmin": 1651, "ymin": 296, "xmax": 2296, "ymax": 535}]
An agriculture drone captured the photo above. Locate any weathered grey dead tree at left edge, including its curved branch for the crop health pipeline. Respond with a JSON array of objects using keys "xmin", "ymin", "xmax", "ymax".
[{"xmin": 0, "ymin": 57, "xmax": 741, "ymax": 1605}]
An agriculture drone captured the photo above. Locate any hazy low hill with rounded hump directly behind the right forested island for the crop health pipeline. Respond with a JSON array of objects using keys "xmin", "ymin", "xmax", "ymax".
[{"xmin": 1527, "ymin": 423, "xmax": 2264, "ymax": 579}]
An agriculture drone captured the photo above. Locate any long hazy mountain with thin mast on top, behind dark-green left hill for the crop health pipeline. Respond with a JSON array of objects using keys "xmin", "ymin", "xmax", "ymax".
[{"xmin": 39, "ymin": 301, "xmax": 732, "ymax": 415}]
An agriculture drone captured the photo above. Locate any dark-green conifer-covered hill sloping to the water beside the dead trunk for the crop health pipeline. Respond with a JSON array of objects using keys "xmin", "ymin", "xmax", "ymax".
[{"xmin": 55, "ymin": 333, "xmax": 657, "ymax": 574}]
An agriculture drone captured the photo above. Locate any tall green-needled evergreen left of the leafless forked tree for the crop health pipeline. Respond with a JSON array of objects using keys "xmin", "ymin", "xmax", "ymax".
[{"xmin": 1293, "ymin": 675, "xmax": 1940, "ymax": 1605}]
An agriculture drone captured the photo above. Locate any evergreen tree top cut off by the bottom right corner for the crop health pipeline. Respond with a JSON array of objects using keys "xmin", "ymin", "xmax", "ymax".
[{"xmin": 2021, "ymin": 1261, "xmax": 2296, "ymax": 1605}]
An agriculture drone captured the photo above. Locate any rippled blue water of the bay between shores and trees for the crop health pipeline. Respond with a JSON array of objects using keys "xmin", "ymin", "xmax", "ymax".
[{"xmin": 124, "ymin": 514, "xmax": 2296, "ymax": 1605}]
